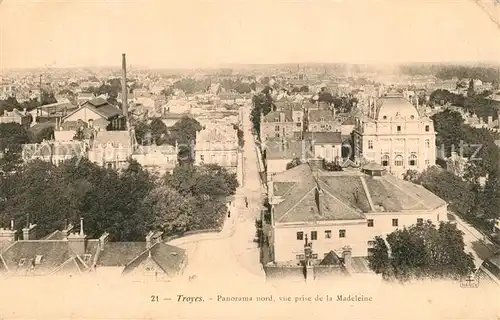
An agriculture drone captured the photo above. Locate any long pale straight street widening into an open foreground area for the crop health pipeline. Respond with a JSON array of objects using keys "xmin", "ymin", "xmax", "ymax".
[{"xmin": 169, "ymin": 107, "xmax": 265, "ymax": 282}]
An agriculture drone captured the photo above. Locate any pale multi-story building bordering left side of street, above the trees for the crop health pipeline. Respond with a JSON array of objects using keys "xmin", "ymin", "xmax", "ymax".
[{"xmin": 194, "ymin": 125, "xmax": 239, "ymax": 173}]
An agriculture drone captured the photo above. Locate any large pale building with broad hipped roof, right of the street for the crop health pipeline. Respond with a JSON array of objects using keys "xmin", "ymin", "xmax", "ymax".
[{"xmin": 268, "ymin": 161, "xmax": 447, "ymax": 265}]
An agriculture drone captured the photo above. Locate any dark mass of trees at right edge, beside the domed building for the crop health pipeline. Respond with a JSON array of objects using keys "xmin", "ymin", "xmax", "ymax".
[{"xmin": 405, "ymin": 110, "xmax": 500, "ymax": 231}]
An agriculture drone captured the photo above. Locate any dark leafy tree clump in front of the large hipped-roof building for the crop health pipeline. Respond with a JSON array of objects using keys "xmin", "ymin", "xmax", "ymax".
[{"xmin": 368, "ymin": 221, "xmax": 475, "ymax": 282}]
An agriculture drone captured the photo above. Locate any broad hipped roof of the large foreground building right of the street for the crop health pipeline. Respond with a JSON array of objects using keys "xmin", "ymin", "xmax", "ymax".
[{"xmin": 273, "ymin": 164, "xmax": 446, "ymax": 223}]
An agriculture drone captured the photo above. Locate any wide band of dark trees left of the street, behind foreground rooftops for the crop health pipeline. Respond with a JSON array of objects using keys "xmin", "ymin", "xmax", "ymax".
[{"xmin": 0, "ymin": 159, "xmax": 237, "ymax": 241}]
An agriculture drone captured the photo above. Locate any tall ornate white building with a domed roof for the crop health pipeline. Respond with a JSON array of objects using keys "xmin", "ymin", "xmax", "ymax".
[{"xmin": 354, "ymin": 94, "xmax": 436, "ymax": 176}]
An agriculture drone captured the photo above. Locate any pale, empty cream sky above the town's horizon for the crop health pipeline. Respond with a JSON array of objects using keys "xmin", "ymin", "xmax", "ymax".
[{"xmin": 0, "ymin": 0, "xmax": 500, "ymax": 68}]
